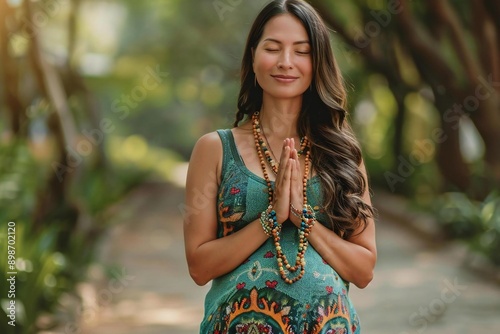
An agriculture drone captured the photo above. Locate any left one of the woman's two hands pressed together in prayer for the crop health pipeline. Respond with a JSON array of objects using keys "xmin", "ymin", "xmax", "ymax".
[{"xmin": 273, "ymin": 138, "xmax": 294, "ymax": 224}]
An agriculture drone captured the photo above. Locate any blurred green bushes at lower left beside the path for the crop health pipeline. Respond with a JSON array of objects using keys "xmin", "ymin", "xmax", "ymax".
[{"xmin": 0, "ymin": 139, "xmax": 149, "ymax": 333}]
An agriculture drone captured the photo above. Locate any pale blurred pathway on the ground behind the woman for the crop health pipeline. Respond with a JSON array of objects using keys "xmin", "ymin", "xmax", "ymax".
[{"xmin": 77, "ymin": 184, "xmax": 500, "ymax": 334}]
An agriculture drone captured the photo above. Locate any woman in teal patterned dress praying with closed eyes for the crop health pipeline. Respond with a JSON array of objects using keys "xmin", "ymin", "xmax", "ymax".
[{"xmin": 184, "ymin": 0, "xmax": 376, "ymax": 334}]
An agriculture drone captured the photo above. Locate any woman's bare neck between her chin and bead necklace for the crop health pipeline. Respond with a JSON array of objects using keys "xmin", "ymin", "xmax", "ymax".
[{"xmin": 260, "ymin": 93, "xmax": 302, "ymax": 140}]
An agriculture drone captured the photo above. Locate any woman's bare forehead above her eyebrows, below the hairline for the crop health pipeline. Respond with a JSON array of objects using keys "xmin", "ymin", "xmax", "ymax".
[{"xmin": 261, "ymin": 14, "xmax": 309, "ymax": 42}]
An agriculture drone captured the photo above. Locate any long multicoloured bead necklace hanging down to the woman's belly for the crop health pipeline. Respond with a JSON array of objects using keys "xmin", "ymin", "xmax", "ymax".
[{"xmin": 252, "ymin": 112, "xmax": 316, "ymax": 284}]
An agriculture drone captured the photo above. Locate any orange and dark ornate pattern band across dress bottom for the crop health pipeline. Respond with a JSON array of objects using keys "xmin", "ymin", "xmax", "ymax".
[{"xmin": 204, "ymin": 280, "xmax": 359, "ymax": 334}]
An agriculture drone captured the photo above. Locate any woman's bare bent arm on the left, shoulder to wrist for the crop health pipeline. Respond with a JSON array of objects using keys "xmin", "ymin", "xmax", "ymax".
[{"xmin": 184, "ymin": 132, "xmax": 267, "ymax": 285}]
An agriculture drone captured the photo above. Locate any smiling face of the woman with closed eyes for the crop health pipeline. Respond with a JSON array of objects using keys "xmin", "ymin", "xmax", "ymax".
[{"xmin": 252, "ymin": 14, "xmax": 312, "ymax": 99}]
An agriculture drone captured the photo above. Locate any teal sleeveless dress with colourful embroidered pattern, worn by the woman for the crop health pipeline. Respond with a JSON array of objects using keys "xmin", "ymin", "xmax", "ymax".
[{"xmin": 200, "ymin": 129, "xmax": 360, "ymax": 334}]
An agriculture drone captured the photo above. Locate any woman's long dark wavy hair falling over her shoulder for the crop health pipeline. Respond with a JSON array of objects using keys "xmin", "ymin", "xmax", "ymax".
[{"xmin": 234, "ymin": 0, "xmax": 374, "ymax": 239}]
